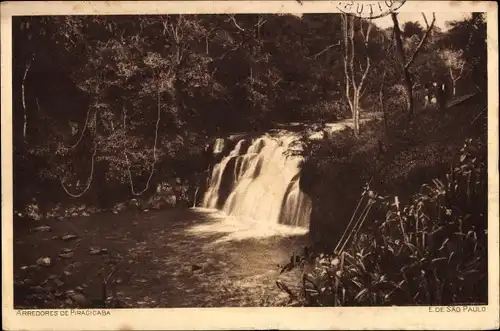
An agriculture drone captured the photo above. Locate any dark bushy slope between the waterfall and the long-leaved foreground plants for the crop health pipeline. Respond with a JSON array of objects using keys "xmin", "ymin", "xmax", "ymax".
[{"xmin": 300, "ymin": 88, "xmax": 487, "ymax": 249}]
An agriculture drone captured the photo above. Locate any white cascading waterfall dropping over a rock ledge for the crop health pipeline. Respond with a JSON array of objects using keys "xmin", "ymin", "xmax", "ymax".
[{"xmin": 202, "ymin": 134, "xmax": 311, "ymax": 228}]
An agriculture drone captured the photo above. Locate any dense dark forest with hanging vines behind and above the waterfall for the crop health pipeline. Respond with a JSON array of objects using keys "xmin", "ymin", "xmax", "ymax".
[{"xmin": 13, "ymin": 14, "xmax": 486, "ymax": 213}]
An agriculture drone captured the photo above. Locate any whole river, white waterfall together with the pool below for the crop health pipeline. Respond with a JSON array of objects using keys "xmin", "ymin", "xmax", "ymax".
[{"xmin": 14, "ymin": 116, "xmax": 378, "ymax": 308}]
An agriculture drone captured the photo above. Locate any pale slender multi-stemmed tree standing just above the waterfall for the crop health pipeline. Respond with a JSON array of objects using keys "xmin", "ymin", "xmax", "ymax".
[{"xmin": 341, "ymin": 14, "xmax": 372, "ymax": 136}]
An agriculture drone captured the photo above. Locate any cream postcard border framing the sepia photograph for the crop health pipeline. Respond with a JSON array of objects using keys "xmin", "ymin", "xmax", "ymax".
[{"xmin": 0, "ymin": 0, "xmax": 500, "ymax": 330}]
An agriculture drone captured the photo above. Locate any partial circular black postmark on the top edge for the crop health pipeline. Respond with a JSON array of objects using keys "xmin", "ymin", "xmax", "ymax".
[{"xmin": 337, "ymin": 0, "xmax": 406, "ymax": 18}]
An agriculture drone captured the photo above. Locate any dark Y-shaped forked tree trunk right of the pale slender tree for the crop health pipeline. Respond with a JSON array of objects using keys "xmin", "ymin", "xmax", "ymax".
[{"xmin": 391, "ymin": 13, "xmax": 436, "ymax": 116}]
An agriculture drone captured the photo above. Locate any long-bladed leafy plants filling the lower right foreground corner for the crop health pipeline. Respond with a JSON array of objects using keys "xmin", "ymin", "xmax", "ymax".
[{"xmin": 280, "ymin": 139, "xmax": 487, "ymax": 306}]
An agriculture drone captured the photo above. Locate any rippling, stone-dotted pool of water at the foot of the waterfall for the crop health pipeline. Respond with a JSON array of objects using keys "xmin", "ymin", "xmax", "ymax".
[{"xmin": 14, "ymin": 208, "xmax": 308, "ymax": 308}]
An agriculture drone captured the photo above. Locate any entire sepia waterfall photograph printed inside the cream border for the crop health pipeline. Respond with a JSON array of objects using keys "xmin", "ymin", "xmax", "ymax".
[{"xmin": 2, "ymin": 1, "xmax": 498, "ymax": 330}]
